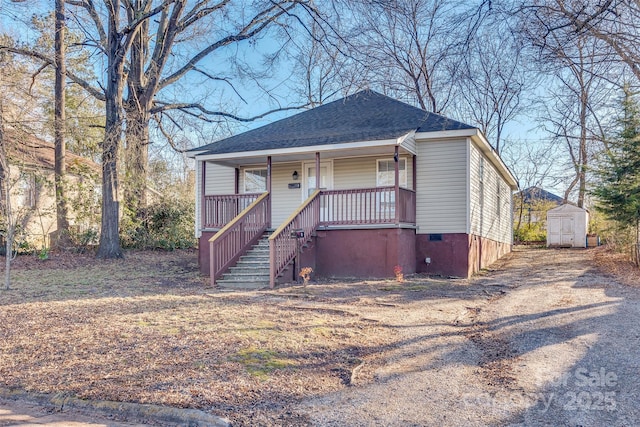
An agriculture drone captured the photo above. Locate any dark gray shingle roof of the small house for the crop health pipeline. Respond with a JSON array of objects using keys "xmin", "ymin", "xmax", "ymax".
[{"xmin": 191, "ymin": 90, "xmax": 473, "ymax": 154}]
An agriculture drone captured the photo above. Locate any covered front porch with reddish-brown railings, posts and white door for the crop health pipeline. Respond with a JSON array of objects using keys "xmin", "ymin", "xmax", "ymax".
[{"xmin": 197, "ymin": 141, "xmax": 416, "ymax": 286}]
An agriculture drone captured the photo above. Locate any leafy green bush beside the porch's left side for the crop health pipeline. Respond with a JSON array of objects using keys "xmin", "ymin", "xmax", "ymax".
[{"xmin": 120, "ymin": 199, "xmax": 196, "ymax": 250}]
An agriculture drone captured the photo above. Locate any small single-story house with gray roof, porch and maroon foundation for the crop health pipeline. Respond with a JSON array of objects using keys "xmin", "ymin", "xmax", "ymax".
[{"xmin": 189, "ymin": 91, "xmax": 517, "ymax": 286}]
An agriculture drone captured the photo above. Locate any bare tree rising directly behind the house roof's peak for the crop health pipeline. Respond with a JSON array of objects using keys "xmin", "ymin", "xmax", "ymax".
[{"xmin": 342, "ymin": 0, "xmax": 467, "ymax": 113}]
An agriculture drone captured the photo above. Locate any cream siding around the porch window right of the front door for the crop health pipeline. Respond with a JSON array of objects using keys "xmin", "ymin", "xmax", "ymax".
[{"xmin": 333, "ymin": 156, "xmax": 413, "ymax": 190}]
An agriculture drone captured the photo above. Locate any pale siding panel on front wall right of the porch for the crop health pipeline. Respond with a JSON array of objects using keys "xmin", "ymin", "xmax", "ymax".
[{"xmin": 416, "ymin": 140, "xmax": 467, "ymax": 234}]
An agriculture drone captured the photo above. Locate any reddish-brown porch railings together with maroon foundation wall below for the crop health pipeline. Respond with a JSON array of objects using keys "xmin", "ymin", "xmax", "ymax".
[{"xmin": 200, "ymin": 187, "xmax": 415, "ymax": 286}]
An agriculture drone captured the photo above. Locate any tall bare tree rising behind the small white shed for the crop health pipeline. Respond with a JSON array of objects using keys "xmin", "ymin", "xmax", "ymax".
[{"xmin": 521, "ymin": 0, "xmax": 619, "ymax": 207}]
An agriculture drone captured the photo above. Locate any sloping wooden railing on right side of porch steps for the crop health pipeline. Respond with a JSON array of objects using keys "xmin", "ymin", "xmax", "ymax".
[{"xmin": 269, "ymin": 190, "xmax": 321, "ymax": 288}]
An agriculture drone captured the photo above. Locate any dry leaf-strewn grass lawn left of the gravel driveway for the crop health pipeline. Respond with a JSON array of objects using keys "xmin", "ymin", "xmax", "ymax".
[{"xmin": 0, "ymin": 251, "xmax": 420, "ymax": 425}]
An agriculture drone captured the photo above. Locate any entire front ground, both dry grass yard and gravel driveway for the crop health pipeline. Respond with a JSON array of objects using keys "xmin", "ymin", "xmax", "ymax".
[{"xmin": 0, "ymin": 248, "xmax": 640, "ymax": 426}]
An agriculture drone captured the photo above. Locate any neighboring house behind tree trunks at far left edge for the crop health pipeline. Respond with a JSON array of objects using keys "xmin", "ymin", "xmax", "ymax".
[{"xmin": 4, "ymin": 128, "xmax": 100, "ymax": 249}]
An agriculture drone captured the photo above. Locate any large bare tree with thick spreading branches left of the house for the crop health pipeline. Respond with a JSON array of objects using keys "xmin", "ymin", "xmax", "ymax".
[{"xmin": 8, "ymin": 0, "xmax": 332, "ymax": 257}]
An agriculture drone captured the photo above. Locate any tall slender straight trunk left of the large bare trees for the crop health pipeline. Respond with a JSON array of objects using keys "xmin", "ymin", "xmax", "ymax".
[{"xmin": 53, "ymin": 0, "xmax": 69, "ymax": 246}]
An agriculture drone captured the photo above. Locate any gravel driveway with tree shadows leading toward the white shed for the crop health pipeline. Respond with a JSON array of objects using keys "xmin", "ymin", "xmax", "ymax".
[{"xmin": 294, "ymin": 249, "xmax": 640, "ymax": 426}]
